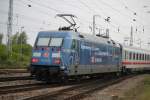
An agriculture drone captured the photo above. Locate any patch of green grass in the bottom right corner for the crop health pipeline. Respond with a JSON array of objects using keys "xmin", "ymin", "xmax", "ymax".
[{"xmin": 121, "ymin": 75, "xmax": 150, "ymax": 100}]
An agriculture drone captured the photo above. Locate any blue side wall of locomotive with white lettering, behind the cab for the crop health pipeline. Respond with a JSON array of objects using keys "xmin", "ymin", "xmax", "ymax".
[{"xmin": 69, "ymin": 33, "xmax": 121, "ymax": 75}]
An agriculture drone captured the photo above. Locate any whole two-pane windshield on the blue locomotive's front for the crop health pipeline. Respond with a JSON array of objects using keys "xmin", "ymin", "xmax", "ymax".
[{"xmin": 36, "ymin": 37, "xmax": 63, "ymax": 46}]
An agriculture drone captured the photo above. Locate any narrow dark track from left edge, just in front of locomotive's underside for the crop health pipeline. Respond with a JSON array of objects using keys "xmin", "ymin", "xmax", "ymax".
[{"xmin": 0, "ymin": 77, "xmax": 99, "ymax": 95}]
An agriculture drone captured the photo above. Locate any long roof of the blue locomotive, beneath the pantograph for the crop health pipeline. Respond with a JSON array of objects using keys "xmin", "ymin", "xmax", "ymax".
[{"xmin": 38, "ymin": 31, "xmax": 120, "ymax": 47}]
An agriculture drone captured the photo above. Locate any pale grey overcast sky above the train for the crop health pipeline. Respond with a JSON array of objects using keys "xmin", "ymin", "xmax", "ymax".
[{"xmin": 0, "ymin": 0, "xmax": 150, "ymax": 48}]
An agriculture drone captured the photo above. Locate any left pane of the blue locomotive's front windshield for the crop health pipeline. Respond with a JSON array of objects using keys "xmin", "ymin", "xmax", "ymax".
[{"xmin": 36, "ymin": 37, "xmax": 50, "ymax": 46}]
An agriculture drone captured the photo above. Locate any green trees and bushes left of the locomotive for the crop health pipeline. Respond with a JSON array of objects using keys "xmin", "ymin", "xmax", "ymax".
[{"xmin": 0, "ymin": 32, "xmax": 32, "ymax": 68}]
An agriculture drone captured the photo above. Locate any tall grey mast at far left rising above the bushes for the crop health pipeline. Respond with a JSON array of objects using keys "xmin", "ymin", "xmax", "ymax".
[{"xmin": 7, "ymin": 0, "xmax": 13, "ymax": 56}]
